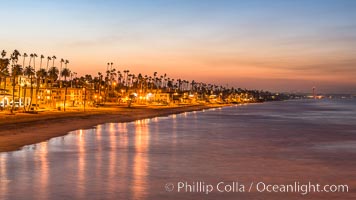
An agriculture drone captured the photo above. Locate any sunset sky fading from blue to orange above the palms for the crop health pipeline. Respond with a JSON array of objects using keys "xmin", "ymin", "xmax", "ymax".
[{"xmin": 0, "ymin": 0, "xmax": 356, "ymax": 94}]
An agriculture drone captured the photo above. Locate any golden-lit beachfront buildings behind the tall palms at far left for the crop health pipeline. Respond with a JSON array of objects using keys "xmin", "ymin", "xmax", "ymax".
[{"xmin": 0, "ymin": 76, "xmax": 94, "ymax": 111}]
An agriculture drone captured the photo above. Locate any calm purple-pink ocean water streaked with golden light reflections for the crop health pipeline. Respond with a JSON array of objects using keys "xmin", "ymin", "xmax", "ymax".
[{"xmin": 0, "ymin": 101, "xmax": 356, "ymax": 200}]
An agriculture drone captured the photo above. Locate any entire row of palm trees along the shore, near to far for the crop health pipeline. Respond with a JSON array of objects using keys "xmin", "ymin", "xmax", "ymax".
[{"xmin": 0, "ymin": 50, "xmax": 286, "ymax": 111}]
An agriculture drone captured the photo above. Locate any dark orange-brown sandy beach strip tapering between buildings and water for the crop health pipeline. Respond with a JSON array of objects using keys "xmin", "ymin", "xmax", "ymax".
[{"xmin": 0, "ymin": 104, "xmax": 228, "ymax": 153}]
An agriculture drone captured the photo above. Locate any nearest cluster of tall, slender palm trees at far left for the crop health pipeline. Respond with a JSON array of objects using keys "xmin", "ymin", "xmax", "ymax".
[{"xmin": 0, "ymin": 50, "xmax": 71, "ymax": 112}]
